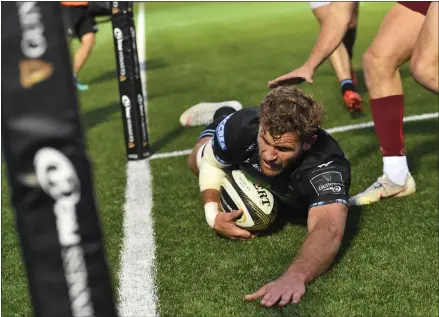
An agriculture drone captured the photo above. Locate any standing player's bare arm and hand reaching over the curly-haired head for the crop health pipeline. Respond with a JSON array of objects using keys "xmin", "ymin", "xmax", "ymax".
[{"xmin": 268, "ymin": 1, "xmax": 355, "ymax": 88}]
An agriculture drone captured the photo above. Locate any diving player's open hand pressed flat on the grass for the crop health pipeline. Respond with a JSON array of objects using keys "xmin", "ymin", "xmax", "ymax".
[{"xmin": 244, "ymin": 274, "xmax": 305, "ymax": 307}]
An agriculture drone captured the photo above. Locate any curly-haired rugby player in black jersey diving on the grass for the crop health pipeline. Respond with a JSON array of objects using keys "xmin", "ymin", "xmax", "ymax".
[{"xmin": 180, "ymin": 87, "xmax": 351, "ymax": 307}]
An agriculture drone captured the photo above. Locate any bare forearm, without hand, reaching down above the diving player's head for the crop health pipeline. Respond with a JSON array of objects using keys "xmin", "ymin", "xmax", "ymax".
[{"xmin": 305, "ymin": 3, "xmax": 351, "ymax": 70}]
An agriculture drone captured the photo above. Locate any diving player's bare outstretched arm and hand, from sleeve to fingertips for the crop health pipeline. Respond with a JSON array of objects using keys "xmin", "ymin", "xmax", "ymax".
[{"xmin": 245, "ymin": 203, "xmax": 348, "ymax": 307}]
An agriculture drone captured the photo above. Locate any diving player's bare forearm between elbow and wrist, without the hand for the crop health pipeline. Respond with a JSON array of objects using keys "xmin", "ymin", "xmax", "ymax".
[{"xmin": 284, "ymin": 223, "xmax": 342, "ymax": 283}]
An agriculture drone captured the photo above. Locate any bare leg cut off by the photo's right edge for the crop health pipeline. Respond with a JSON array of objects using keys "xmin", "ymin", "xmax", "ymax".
[{"xmin": 410, "ymin": 2, "xmax": 439, "ymax": 93}]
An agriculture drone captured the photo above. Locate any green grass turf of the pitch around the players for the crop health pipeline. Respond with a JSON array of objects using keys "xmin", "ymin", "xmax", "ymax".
[{"xmin": 1, "ymin": 3, "xmax": 438, "ymax": 317}]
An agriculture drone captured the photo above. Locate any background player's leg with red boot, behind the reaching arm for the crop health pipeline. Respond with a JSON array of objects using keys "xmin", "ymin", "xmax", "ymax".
[{"xmin": 310, "ymin": 2, "xmax": 363, "ymax": 114}]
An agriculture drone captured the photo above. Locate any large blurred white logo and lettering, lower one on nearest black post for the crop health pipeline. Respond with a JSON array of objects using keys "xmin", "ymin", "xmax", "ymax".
[{"xmin": 34, "ymin": 147, "xmax": 94, "ymax": 317}]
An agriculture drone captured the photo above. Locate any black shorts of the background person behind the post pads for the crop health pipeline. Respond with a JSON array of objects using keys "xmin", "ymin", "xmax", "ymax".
[{"xmin": 62, "ymin": 6, "xmax": 98, "ymax": 39}]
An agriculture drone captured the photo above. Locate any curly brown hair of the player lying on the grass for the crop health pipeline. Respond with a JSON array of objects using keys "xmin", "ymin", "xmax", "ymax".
[{"xmin": 259, "ymin": 86, "xmax": 324, "ymax": 141}]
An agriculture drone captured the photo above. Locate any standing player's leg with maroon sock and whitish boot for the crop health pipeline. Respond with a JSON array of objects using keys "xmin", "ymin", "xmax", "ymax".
[{"xmin": 351, "ymin": 3, "xmax": 424, "ymax": 205}]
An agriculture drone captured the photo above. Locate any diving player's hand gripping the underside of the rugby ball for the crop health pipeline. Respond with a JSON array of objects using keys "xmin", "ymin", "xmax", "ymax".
[{"xmin": 213, "ymin": 210, "xmax": 254, "ymax": 239}]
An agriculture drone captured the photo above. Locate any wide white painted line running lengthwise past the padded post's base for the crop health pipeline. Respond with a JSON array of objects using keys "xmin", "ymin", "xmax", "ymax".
[{"xmin": 119, "ymin": 3, "xmax": 159, "ymax": 317}]
